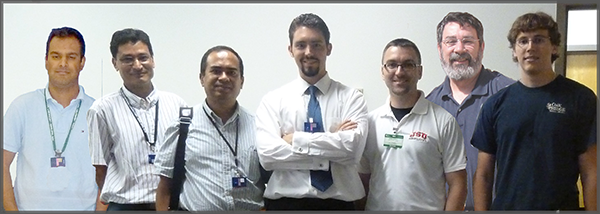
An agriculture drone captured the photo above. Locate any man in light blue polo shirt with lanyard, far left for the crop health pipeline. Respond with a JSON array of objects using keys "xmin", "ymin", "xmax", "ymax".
[{"xmin": 2, "ymin": 27, "xmax": 98, "ymax": 211}]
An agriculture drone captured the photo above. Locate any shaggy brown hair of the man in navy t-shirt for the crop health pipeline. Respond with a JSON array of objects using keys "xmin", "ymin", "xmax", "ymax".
[{"xmin": 507, "ymin": 12, "xmax": 560, "ymax": 62}]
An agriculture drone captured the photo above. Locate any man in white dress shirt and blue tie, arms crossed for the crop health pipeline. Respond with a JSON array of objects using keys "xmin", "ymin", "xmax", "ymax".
[{"xmin": 256, "ymin": 13, "xmax": 368, "ymax": 210}]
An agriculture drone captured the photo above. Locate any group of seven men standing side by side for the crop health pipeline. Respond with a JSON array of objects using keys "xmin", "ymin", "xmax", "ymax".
[{"xmin": 3, "ymin": 12, "xmax": 597, "ymax": 211}]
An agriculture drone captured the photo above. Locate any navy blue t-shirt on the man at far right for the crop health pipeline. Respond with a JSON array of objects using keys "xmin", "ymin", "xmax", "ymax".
[{"xmin": 471, "ymin": 75, "xmax": 597, "ymax": 210}]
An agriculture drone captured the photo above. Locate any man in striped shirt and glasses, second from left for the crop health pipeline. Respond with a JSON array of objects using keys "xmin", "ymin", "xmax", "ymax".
[{"xmin": 87, "ymin": 28, "xmax": 186, "ymax": 211}]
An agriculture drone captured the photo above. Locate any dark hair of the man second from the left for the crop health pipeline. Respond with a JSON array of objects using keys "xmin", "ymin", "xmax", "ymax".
[{"xmin": 110, "ymin": 28, "xmax": 154, "ymax": 58}]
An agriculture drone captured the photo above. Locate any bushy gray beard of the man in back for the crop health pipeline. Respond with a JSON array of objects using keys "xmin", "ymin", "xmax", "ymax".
[{"xmin": 440, "ymin": 50, "xmax": 481, "ymax": 80}]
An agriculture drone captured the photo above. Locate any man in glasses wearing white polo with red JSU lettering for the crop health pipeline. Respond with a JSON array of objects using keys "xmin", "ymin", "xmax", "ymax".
[{"xmin": 359, "ymin": 38, "xmax": 467, "ymax": 211}]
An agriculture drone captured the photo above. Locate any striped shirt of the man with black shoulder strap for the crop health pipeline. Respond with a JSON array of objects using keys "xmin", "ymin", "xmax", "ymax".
[{"xmin": 155, "ymin": 102, "xmax": 264, "ymax": 211}]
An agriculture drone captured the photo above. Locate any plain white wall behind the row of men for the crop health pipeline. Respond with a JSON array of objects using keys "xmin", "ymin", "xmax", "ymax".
[{"xmin": 2, "ymin": 3, "xmax": 556, "ymax": 182}]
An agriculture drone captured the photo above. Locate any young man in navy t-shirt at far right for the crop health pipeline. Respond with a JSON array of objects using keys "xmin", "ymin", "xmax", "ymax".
[{"xmin": 471, "ymin": 12, "xmax": 597, "ymax": 210}]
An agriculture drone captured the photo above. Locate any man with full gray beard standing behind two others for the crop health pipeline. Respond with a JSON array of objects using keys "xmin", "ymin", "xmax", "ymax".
[{"xmin": 426, "ymin": 12, "xmax": 515, "ymax": 210}]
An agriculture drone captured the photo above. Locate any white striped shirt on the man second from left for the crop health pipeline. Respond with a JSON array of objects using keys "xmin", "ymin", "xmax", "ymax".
[{"xmin": 87, "ymin": 87, "xmax": 186, "ymax": 204}]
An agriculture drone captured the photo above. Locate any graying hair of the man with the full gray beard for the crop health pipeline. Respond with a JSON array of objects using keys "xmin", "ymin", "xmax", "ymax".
[{"xmin": 437, "ymin": 12, "xmax": 483, "ymax": 47}]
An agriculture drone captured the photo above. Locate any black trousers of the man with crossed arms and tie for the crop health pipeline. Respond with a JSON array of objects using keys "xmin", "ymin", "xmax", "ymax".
[{"xmin": 264, "ymin": 197, "xmax": 355, "ymax": 211}]
